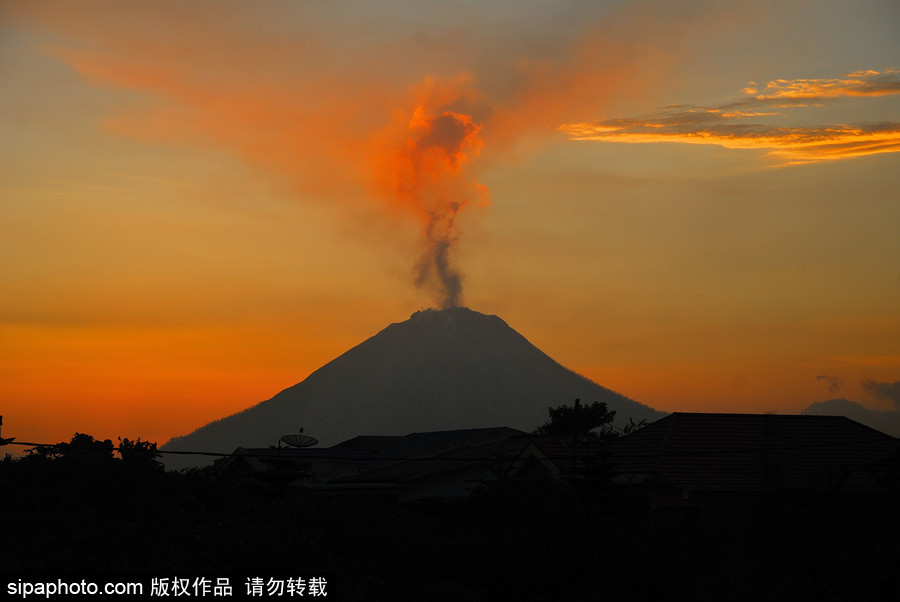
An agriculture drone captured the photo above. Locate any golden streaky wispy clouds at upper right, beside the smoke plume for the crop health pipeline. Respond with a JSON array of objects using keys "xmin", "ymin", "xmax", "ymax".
[{"xmin": 559, "ymin": 70, "xmax": 900, "ymax": 165}]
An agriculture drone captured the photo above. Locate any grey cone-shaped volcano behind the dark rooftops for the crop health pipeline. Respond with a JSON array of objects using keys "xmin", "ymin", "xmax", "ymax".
[{"xmin": 162, "ymin": 307, "xmax": 664, "ymax": 465}]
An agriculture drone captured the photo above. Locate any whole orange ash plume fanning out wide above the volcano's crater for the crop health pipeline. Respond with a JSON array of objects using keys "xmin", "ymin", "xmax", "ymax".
[{"xmin": 5, "ymin": 0, "xmax": 740, "ymax": 305}]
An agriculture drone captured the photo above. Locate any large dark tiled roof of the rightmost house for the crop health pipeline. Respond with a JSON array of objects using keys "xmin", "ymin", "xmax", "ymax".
[{"xmin": 612, "ymin": 412, "xmax": 898, "ymax": 491}]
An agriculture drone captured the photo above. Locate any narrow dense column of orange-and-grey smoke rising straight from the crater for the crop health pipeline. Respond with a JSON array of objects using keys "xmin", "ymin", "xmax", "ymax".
[{"xmin": 394, "ymin": 107, "xmax": 488, "ymax": 309}]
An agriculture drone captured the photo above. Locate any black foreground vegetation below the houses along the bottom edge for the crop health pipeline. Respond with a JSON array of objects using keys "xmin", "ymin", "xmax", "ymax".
[{"xmin": 0, "ymin": 436, "xmax": 900, "ymax": 602}]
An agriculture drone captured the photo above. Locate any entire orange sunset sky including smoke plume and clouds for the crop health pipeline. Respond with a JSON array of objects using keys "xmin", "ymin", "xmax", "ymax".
[{"xmin": 0, "ymin": 0, "xmax": 900, "ymax": 449}]
